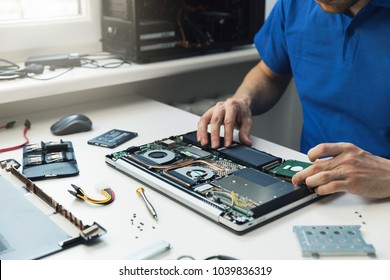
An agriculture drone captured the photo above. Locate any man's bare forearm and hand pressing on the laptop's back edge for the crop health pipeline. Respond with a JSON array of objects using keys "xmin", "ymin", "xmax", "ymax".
[{"xmin": 197, "ymin": 61, "xmax": 291, "ymax": 149}]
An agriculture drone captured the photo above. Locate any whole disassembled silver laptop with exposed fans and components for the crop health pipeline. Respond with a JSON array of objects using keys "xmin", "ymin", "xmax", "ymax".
[{"xmin": 105, "ymin": 131, "xmax": 318, "ymax": 234}]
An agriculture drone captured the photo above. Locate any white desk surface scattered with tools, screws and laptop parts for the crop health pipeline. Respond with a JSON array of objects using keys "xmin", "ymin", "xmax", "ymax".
[{"xmin": 0, "ymin": 96, "xmax": 390, "ymax": 259}]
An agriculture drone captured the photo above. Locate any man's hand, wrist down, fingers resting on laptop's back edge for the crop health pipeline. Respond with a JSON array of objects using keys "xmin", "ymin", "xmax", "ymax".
[{"xmin": 197, "ymin": 98, "xmax": 252, "ymax": 149}]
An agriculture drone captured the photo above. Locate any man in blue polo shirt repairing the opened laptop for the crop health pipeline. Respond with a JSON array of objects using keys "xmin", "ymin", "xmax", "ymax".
[{"xmin": 198, "ymin": 0, "xmax": 390, "ymax": 198}]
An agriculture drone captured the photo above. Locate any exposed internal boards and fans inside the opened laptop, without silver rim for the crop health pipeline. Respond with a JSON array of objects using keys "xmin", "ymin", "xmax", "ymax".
[{"xmin": 106, "ymin": 132, "xmax": 312, "ymax": 234}]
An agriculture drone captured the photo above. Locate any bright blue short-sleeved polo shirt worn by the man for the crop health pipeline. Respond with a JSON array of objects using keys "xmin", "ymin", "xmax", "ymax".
[{"xmin": 255, "ymin": 0, "xmax": 390, "ymax": 158}]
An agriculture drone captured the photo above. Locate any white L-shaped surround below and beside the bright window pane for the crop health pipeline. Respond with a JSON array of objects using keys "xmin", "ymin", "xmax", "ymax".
[{"xmin": 0, "ymin": 0, "xmax": 102, "ymax": 62}]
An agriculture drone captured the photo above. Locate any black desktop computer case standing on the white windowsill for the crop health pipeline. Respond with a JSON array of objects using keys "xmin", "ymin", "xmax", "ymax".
[{"xmin": 102, "ymin": 0, "xmax": 265, "ymax": 63}]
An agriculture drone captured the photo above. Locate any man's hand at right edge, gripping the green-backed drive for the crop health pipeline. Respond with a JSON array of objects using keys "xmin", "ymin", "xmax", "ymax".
[{"xmin": 292, "ymin": 143, "xmax": 390, "ymax": 198}]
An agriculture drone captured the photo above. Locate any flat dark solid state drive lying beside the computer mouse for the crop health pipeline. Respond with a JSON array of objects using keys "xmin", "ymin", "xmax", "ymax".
[{"xmin": 88, "ymin": 129, "xmax": 138, "ymax": 149}]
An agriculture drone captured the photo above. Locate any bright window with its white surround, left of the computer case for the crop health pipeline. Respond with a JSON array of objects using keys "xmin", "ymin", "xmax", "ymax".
[{"xmin": 0, "ymin": 0, "xmax": 101, "ymax": 62}]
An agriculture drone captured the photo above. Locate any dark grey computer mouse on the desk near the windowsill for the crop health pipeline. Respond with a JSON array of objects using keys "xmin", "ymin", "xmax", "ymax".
[{"xmin": 50, "ymin": 114, "xmax": 92, "ymax": 135}]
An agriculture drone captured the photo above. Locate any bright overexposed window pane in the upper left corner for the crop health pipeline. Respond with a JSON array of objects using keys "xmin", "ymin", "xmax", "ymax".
[{"xmin": 0, "ymin": 0, "xmax": 82, "ymax": 22}]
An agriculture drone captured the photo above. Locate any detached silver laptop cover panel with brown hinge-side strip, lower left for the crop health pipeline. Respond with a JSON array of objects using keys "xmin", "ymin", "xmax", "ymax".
[{"xmin": 0, "ymin": 161, "xmax": 106, "ymax": 260}]
